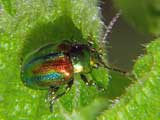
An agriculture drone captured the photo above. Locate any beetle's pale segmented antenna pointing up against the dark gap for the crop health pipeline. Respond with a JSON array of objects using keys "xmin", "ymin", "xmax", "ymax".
[{"xmin": 102, "ymin": 11, "xmax": 121, "ymax": 41}]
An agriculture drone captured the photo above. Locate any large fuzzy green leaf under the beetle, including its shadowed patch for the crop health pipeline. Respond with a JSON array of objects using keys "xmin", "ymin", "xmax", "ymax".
[{"xmin": 0, "ymin": 0, "xmax": 108, "ymax": 120}]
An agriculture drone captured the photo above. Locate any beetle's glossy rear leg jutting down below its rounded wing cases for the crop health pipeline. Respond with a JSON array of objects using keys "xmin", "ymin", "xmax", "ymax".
[{"xmin": 48, "ymin": 79, "xmax": 73, "ymax": 112}]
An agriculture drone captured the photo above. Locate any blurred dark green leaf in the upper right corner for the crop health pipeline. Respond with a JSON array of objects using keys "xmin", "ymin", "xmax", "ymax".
[{"xmin": 114, "ymin": 0, "xmax": 160, "ymax": 36}]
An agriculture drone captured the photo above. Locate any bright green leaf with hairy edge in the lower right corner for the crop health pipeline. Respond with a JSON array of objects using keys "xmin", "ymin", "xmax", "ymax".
[{"xmin": 98, "ymin": 38, "xmax": 160, "ymax": 120}]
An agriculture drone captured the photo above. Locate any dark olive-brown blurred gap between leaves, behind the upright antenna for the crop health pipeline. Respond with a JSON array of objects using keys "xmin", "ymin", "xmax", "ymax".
[{"xmin": 100, "ymin": 0, "xmax": 152, "ymax": 71}]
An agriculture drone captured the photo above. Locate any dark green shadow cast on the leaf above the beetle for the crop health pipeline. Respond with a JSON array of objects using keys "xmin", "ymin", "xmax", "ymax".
[{"xmin": 21, "ymin": 16, "xmax": 84, "ymax": 58}]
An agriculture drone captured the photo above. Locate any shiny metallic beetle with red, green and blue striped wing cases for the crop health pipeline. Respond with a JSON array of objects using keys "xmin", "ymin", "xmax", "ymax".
[{"xmin": 21, "ymin": 13, "xmax": 120, "ymax": 111}]
